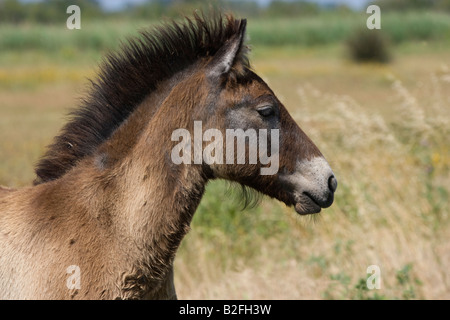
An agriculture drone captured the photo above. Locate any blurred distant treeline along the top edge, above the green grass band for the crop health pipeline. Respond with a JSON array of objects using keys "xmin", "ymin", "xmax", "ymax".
[{"xmin": 0, "ymin": 0, "xmax": 450, "ymax": 24}]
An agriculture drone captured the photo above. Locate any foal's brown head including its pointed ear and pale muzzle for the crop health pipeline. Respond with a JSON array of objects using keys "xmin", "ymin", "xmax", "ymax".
[{"xmin": 166, "ymin": 20, "xmax": 337, "ymax": 214}]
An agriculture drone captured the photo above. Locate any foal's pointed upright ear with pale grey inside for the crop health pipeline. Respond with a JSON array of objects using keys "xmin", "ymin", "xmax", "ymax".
[{"xmin": 207, "ymin": 19, "xmax": 247, "ymax": 78}]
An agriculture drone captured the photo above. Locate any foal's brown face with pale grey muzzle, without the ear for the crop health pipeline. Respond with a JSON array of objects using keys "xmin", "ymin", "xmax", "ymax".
[{"xmin": 203, "ymin": 71, "xmax": 337, "ymax": 214}]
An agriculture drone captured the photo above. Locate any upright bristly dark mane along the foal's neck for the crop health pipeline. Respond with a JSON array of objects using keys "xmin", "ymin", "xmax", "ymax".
[{"xmin": 34, "ymin": 13, "xmax": 249, "ymax": 184}]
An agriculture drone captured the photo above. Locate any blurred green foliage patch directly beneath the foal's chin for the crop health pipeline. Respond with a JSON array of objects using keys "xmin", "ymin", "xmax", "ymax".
[{"xmin": 192, "ymin": 180, "xmax": 290, "ymax": 260}]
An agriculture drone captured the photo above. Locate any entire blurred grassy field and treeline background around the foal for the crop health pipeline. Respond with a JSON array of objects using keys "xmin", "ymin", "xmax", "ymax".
[{"xmin": 0, "ymin": 0, "xmax": 450, "ymax": 299}]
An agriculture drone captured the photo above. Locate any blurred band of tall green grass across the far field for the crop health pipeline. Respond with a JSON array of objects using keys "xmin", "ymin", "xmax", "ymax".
[{"xmin": 0, "ymin": 12, "xmax": 450, "ymax": 53}]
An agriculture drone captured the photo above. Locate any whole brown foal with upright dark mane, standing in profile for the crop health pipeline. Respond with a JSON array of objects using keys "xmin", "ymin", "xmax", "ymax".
[{"xmin": 0, "ymin": 12, "xmax": 336, "ymax": 299}]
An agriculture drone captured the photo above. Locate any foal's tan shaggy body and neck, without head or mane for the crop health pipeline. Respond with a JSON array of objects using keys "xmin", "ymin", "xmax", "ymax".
[{"xmin": 0, "ymin": 73, "xmax": 201, "ymax": 299}]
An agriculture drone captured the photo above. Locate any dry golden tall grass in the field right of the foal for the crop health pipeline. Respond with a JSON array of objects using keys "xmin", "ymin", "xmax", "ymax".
[{"xmin": 176, "ymin": 48, "xmax": 450, "ymax": 299}]
